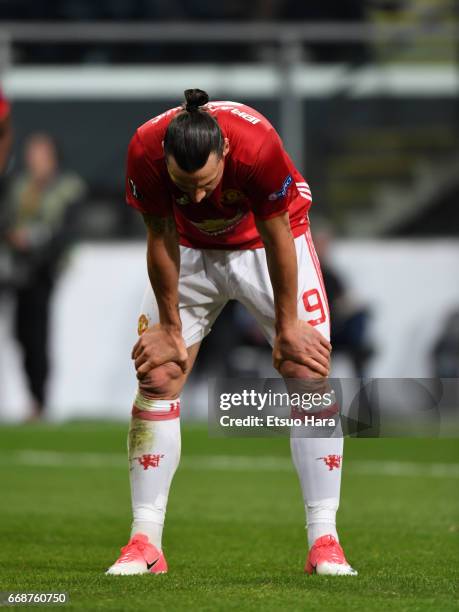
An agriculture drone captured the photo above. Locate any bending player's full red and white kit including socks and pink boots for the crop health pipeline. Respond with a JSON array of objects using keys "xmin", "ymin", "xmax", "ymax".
[{"xmin": 108, "ymin": 102, "xmax": 353, "ymax": 575}]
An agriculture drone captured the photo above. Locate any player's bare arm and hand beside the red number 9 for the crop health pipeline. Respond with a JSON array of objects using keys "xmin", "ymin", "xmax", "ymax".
[{"xmin": 256, "ymin": 212, "xmax": 331, "ymax": 376}]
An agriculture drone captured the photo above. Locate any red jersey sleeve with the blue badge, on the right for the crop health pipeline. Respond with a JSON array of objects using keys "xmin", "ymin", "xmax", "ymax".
[{"xmin": 246, "ymin": 129, "xmax": 297, "ymax": 219}]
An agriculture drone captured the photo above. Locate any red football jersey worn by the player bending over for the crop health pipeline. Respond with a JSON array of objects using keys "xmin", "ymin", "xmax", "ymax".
[{"xmin": 126, "ymin": 102, "xmax": 311, "ymax": 249}]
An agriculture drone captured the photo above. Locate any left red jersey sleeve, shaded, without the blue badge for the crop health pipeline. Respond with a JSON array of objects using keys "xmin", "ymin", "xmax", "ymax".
[{"xmin": 126, "ymin": 132, "xmax": 173, "ymax": 217}]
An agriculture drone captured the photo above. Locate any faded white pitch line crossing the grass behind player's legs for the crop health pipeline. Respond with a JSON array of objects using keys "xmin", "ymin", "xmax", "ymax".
[{"xmin": 0, "ymin": 450, "xmax": 459, "ymax": 478}]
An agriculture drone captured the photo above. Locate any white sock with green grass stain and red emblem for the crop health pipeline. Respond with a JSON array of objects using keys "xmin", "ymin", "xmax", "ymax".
[{"xmin": 128, "ymin": 393, "xmax": 181, "ymax": 550}]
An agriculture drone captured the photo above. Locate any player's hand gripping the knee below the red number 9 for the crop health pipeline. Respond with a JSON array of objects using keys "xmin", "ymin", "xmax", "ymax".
[{"xmin": 273, "ymin": 320, "xmax": 331, "ymax": 377}]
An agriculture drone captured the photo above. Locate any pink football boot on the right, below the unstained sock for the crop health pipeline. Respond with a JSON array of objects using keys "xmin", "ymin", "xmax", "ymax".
[{"xmin": 304, "ymin": 535, "xmax": 357, "ymax": 576}]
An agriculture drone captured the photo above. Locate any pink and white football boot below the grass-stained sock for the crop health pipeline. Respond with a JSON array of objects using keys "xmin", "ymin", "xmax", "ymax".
[{"xmin": 105, "ymin": 533, "xmax": 167, "ymax": 576}]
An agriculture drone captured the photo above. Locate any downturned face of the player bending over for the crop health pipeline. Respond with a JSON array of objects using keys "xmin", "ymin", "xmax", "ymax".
[{"xmin": 166, "ymin": 138, "xmax": 229, "ymax": 204}]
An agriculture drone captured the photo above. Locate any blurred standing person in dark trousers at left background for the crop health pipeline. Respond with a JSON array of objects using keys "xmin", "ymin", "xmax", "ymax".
[{"xmin": 5, "ymin": 134, "xmax": 85, "ymax": 418}]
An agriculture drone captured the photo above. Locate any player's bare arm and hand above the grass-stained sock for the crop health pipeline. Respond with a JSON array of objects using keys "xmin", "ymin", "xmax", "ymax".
[{"xmin": 132, "ymin": 214, "xmax": 188, "ymax": 379}]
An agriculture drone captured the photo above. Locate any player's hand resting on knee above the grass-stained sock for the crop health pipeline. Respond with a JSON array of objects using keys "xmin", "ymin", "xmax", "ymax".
[{"xmin": 131, "ymin": 324, "xmax": 188, "ymax": 380}]
